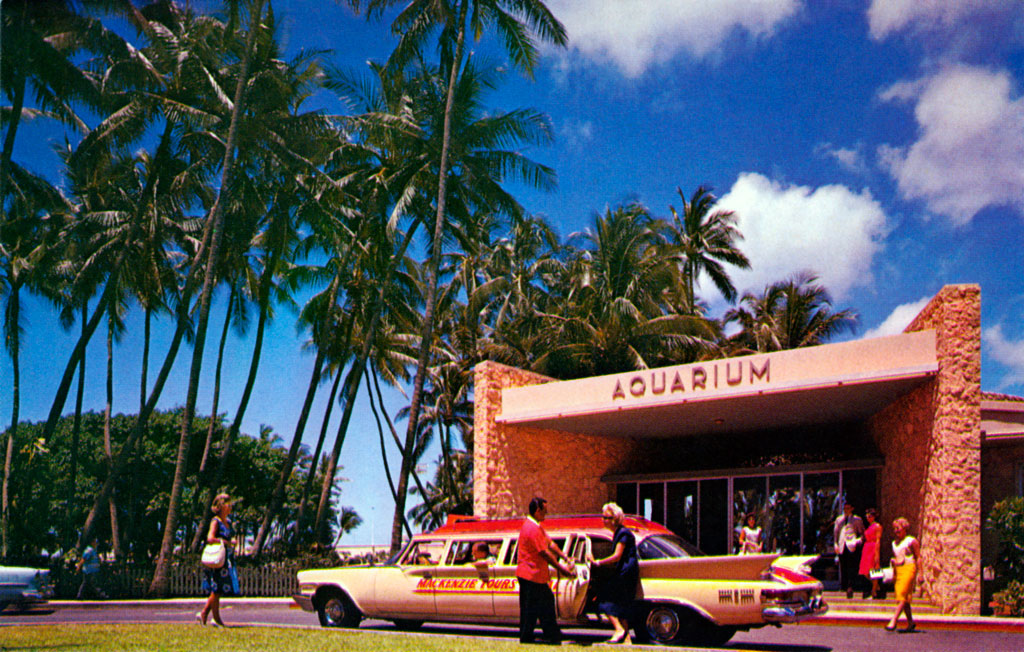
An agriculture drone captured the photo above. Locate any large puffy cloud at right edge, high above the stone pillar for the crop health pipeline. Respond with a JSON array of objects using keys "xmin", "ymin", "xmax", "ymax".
[{"xmin": 878, "ymin": 66, "xmax": 1024, "ymax": 225}]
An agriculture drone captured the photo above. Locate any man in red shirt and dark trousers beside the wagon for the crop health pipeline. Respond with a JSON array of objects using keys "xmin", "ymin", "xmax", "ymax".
[{"xmin": 515, "ymin": 497, "xmax": 575, "ymax": 645}]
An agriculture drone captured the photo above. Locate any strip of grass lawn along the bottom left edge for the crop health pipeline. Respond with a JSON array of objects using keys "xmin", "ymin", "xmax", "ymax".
[{"xmin": 0, "ymin": 623, "xmax": 598, "ymax": 652}]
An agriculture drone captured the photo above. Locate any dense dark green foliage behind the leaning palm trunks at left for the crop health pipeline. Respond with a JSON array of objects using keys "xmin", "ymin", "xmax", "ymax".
[{"xmin": 3, "ymin": 410, "xmax": 337, "ymax": 564}]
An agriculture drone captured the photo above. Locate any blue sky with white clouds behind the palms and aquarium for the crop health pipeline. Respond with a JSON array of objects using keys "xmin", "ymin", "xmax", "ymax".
[{"xmin": 0, "ymin": 0, "xmax": 1024, "ymax": 544}]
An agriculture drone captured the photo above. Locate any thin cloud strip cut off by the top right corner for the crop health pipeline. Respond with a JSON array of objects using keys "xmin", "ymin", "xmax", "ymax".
[{"xmin": 867, "ymin": 0, "xmax": 1022, "ymax": 40}]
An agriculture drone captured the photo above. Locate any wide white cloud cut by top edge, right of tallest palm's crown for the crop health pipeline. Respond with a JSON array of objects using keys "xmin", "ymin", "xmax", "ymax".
[{"xmin": 548, "ymin": 0, "xmax": 801, "ymax": 77}]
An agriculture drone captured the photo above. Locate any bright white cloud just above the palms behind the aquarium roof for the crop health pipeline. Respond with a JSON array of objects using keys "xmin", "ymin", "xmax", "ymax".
[{"xmin": 718, "ymin": 172, "xmax": 887, "ymax": 301}]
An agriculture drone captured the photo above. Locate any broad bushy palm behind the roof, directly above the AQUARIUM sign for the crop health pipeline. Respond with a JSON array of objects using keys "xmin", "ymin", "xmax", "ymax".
[{"xmin": 532, "ymin": 204, "xmax": 717, "ymax": 378}]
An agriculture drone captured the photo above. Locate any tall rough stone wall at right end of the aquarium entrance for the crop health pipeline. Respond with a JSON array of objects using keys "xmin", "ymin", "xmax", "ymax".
[{"xmin": 870, "ymin": 285, "xmax": 981, "ymax": 614}]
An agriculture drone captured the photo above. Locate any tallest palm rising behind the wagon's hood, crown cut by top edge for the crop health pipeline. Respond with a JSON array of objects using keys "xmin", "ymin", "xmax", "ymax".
[{"xmin": 349, "ymin": 0, "xmax": 567, "ymax": 552}]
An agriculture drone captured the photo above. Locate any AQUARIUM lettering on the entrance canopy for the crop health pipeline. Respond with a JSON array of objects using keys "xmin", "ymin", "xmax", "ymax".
[{"xmin": 611, "ymin": 358, "xmax": 771, "ymax": 400}]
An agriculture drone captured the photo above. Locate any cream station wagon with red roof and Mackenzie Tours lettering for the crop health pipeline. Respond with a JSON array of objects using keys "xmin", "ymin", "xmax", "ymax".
[{"xmin": 294, "ymin": 516, "xmax": 827, "ymax": 645}]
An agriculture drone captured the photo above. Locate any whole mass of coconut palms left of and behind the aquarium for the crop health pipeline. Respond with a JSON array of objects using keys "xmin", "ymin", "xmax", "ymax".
[{"xmin": 0, "ymin": 0, "xmax": 855, "ymax": 594}]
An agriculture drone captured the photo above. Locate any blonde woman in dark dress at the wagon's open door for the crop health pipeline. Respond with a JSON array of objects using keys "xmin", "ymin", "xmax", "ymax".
[{"xmin": 587, "ymin": 503, "xmax": 640, "ymax": 643}]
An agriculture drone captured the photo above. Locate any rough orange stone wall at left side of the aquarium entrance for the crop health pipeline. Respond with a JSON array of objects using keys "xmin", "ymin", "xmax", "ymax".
[{"xmin": 473, "ymin": 361, "xmax": 634, "ymax": 518}]
